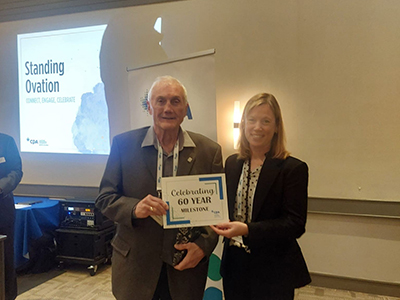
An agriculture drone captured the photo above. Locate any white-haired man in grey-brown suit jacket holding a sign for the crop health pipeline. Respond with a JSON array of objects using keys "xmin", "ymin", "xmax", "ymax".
[{"xmin": 96, "ymin": 76, "xmax": 223, "ymax": 300}]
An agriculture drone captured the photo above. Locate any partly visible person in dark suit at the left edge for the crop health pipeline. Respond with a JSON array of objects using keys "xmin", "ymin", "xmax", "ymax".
[{"xmin": 0, "ymin": 133, "xmax": 22, "ymax": 300}]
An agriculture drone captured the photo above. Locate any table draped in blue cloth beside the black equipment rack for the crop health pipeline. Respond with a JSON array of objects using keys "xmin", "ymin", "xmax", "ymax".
[{"xmin": 14, "ymin": 196, "xmax": 60, "ymax": 269}]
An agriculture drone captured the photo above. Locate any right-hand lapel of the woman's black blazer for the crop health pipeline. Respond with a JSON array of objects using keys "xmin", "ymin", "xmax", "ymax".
[{"xmin": 252, "ymin": 159, "xmax": 282, "ymax": 220}]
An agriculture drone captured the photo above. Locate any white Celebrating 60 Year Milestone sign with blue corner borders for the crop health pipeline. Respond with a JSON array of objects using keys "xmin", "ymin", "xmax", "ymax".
[{"xmin": 161, "ymin": 174, "xmax": 229, "ymax": 228}]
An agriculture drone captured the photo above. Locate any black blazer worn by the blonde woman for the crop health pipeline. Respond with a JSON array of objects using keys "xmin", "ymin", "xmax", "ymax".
[{"xmin": 221, "ymin": 154, "xmax": 311, "ymax": 290}]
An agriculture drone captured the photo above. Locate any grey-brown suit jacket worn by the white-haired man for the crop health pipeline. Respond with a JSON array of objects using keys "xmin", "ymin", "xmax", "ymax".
[{"xmin": 96, "ymin": 127, "xmax": 223, "ymax": 300}]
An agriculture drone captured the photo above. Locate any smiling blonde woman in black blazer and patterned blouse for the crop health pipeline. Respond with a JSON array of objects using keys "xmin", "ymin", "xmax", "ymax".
[{"xmin": 212, "ymin": 93, "xmax": 311, "ymax": 300}]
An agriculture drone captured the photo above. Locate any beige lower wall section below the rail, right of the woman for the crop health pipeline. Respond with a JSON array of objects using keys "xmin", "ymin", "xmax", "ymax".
[{"xmin": 300, "ymin": 214, "xmax": 400, "ymax": 284}]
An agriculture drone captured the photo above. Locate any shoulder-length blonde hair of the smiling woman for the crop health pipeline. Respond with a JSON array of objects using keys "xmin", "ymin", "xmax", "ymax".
[{"xmin": 238, "ymin": 93, "xmax": 290, "ymax": 159}]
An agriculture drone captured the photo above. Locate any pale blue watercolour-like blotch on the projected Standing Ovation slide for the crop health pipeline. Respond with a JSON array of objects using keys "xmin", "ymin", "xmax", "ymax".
[{"xmin": 72, "ymin": 82, "xmax": 110, "ymax": 154}]
